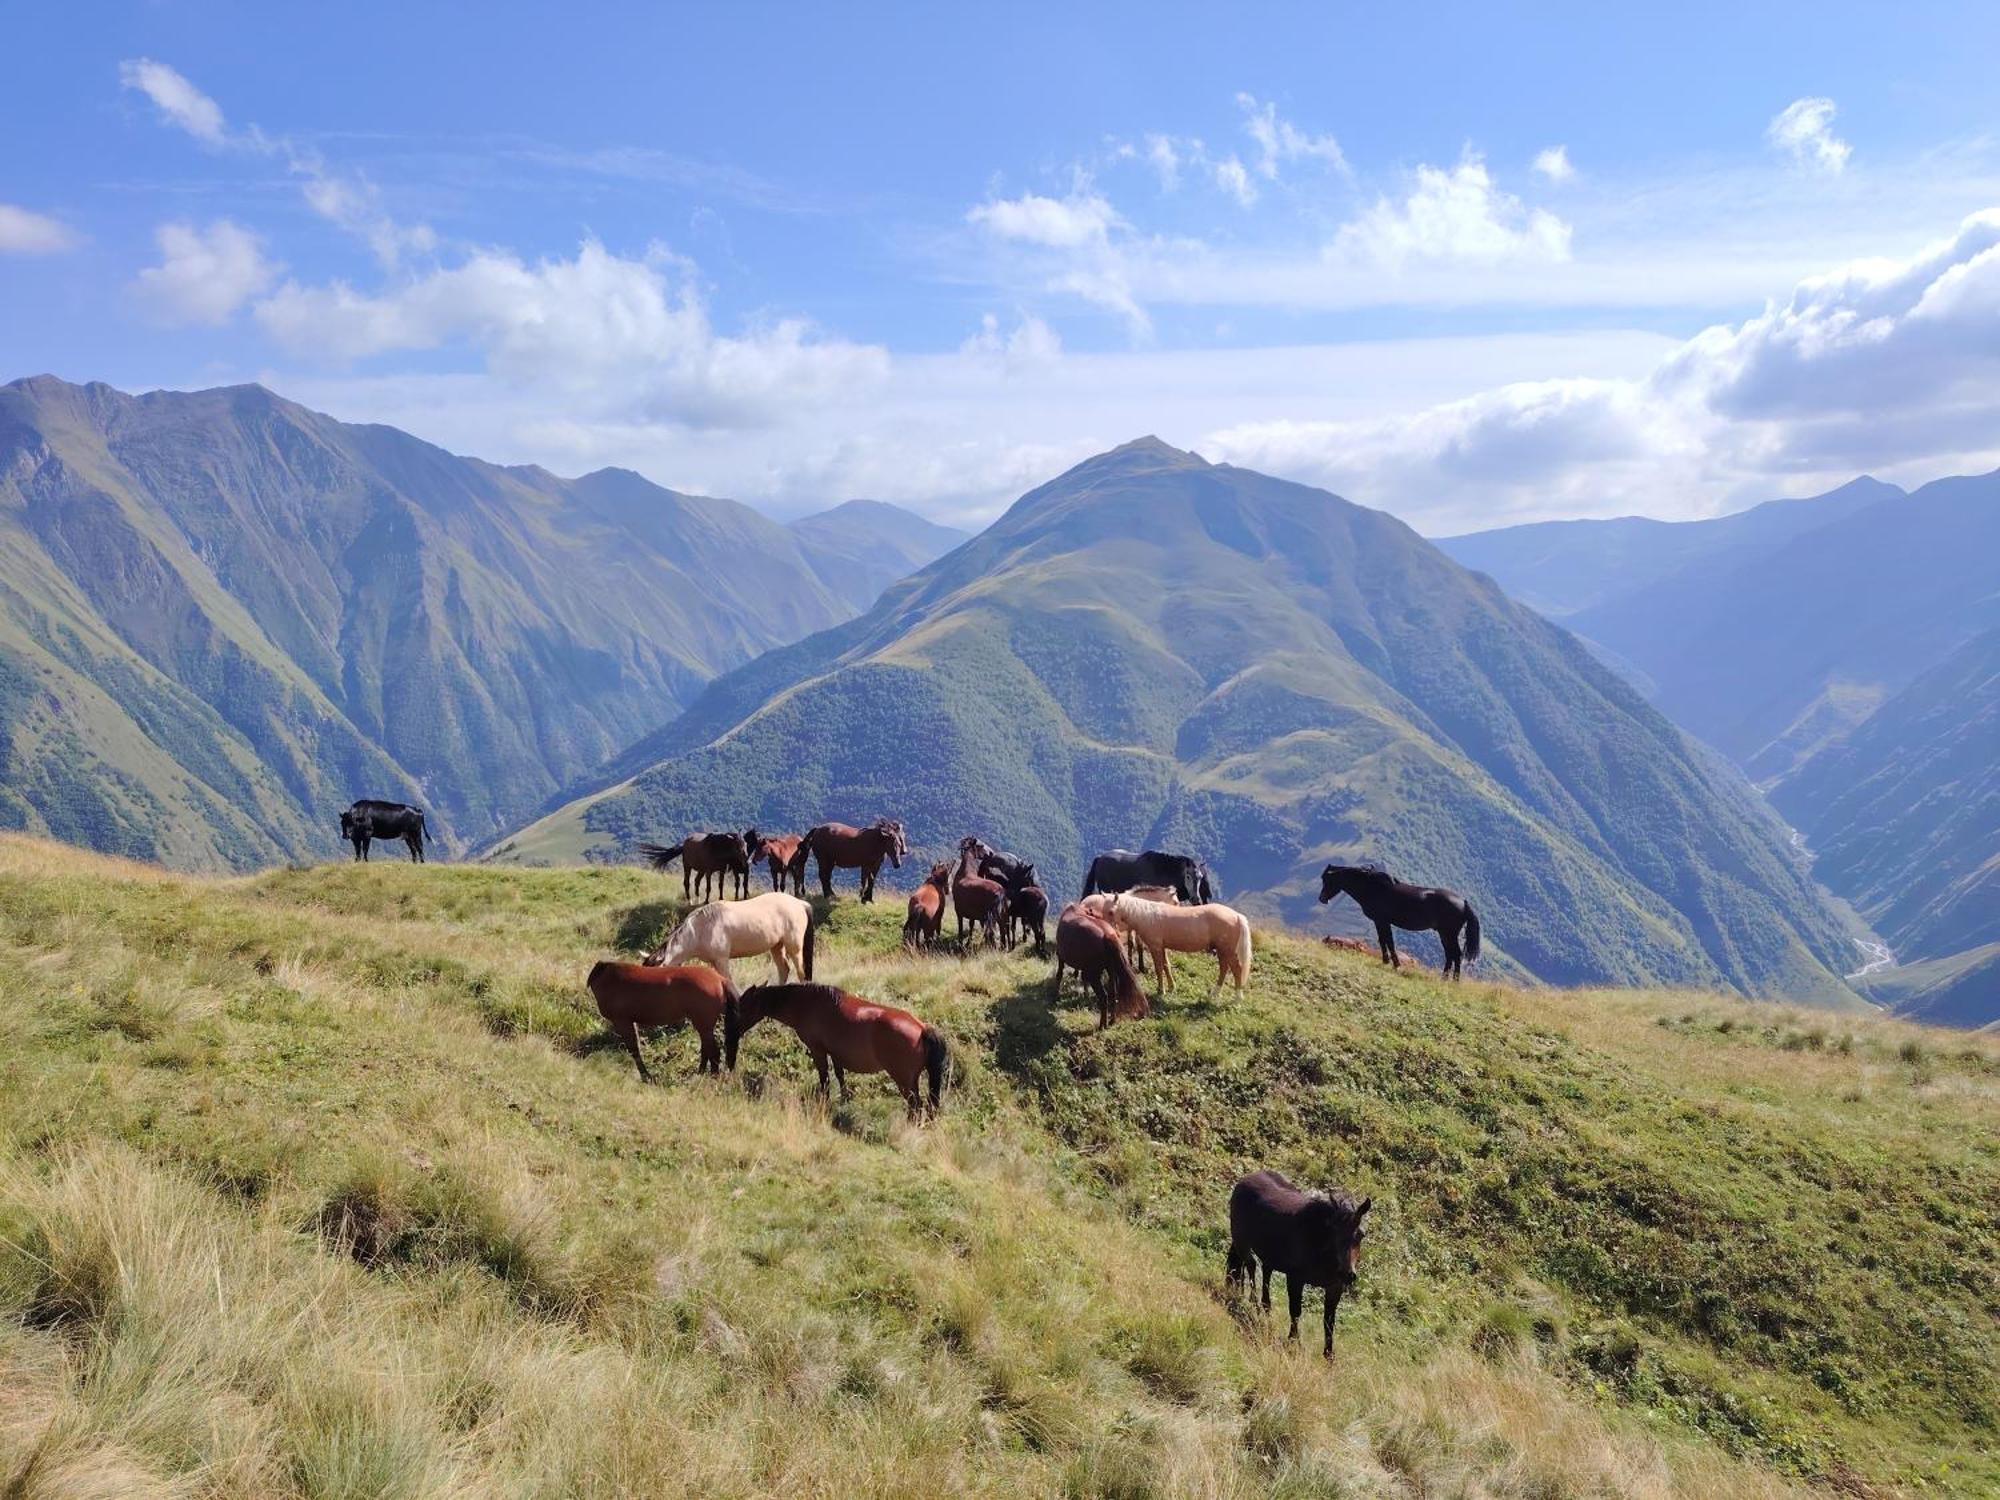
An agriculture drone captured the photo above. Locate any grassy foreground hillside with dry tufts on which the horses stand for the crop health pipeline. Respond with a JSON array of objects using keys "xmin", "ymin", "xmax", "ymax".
[{"xmin": 0, "ymin": 838, "xmax": 2000, "ymax": 1500}]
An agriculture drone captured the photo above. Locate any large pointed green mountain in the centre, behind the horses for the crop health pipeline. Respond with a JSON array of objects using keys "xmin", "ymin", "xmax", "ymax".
[{"xmin": 500, "ymin": 440, "xmax": 1854, "ymax": 1004}]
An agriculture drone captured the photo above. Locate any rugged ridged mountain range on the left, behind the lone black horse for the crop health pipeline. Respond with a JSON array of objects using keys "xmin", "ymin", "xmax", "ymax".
[{"xmin": 0, "ymin": 376, "xmax": 958, "ymax": 868}]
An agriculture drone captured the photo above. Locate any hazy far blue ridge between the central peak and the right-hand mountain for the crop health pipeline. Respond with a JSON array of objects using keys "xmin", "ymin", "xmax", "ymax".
[{"xmin": 1438, "ymin": 476, "xmax": 1902, "ymax": 620}]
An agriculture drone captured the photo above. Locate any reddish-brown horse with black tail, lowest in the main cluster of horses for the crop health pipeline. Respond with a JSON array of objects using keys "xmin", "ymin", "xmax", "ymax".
[{"xmin": 722, "ymin": 984, "xmax": 948, "ymax": 1116}]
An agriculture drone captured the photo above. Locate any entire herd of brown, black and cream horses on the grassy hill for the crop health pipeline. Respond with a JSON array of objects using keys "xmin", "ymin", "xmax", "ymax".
[{"xmin": 340, "ymin": 800, "xmax": 1480, "ymax": 1358}]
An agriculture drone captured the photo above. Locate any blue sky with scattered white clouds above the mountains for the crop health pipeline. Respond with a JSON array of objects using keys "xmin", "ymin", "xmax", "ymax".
[{"xmin": 0, "ymin": 0, "xmax": 2000, "ymax": 532}]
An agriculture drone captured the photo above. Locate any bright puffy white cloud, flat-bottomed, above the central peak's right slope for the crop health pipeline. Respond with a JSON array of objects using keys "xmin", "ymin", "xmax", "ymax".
[{"xmin": 1332, "ymin": 152, "xmax": 1570, "ymax": 268}]
